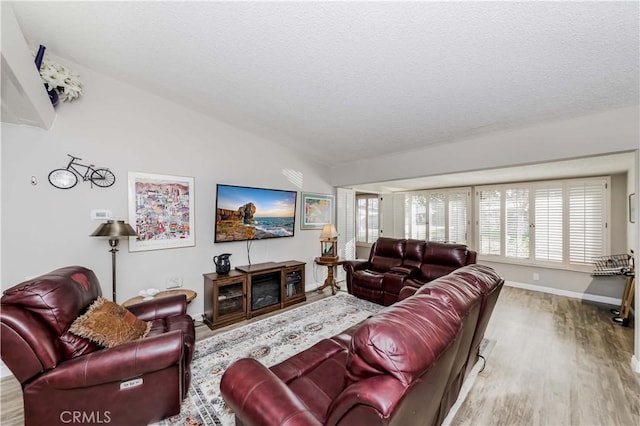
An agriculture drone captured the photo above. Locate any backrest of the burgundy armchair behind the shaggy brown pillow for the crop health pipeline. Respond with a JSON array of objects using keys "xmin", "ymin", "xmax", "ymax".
[{"xmin": 0, "ymin": 266, "xmax": 102, "ymax": 382}]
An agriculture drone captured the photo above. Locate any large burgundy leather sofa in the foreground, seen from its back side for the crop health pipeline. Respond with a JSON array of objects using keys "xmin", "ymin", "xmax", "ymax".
[{"xmin": 220, "ymin": 265, "xmax": 503, "ymax": 426}]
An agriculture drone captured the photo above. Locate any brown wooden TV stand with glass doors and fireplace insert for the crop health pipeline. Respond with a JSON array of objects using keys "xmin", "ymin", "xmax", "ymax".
[{"xmin": 204, "ymin": 260, "xmax": 307, "ymax": 329}]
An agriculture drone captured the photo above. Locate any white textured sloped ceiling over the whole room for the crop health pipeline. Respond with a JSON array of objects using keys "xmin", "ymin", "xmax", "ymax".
[{"xmin": 6, "ymin": 1, "xmax": 639, "ymax": 172}]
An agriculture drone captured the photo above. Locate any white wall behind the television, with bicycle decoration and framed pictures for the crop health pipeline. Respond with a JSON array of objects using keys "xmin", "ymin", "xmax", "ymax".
[{"xmin": 1, "ymin": 58, "xmax": 333, "ymax": 315}]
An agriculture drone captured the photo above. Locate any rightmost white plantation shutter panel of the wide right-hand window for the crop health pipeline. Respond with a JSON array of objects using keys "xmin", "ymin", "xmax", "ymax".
[{"xmin": 569, "ymin": 179, "xmax": 607, "ymax": 264}]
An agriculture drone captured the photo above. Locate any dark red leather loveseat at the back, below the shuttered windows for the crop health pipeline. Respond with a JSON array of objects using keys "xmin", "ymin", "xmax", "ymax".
[{"xmin": 343, "ymin": 237, "xmax": 477, "ymax": 306}]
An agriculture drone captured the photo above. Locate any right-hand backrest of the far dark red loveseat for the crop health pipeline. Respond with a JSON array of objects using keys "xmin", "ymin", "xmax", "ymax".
[{"xmin": 420, "ymin": 241, "xmax": 475, "ymax": 282}]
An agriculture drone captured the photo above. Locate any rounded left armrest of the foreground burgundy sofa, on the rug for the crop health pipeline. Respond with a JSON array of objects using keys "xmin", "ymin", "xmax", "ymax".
[{"xmin": 220, "ymin": 358, "xmax": 321, "ymax": 426}]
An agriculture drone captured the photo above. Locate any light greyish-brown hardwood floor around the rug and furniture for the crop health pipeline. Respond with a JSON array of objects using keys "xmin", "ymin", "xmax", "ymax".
[{"xmin": 0, "ymin": 287, "xmax": 640, "ymax": 426}]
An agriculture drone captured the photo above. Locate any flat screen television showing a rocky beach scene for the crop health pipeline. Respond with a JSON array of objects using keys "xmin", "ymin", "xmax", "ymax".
[{"xmin": 215, "ymin": 184, "xmax": 298, "ymax": 243}]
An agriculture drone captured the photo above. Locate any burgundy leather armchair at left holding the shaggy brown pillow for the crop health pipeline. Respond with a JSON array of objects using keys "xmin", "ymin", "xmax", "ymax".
[{"xmin": 0, "ymin": 266, "xmax": 195, "ymax": 426}]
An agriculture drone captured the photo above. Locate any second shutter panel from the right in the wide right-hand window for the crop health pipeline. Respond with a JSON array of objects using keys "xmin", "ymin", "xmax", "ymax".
[{"xmin": 534, "ymin": 184, "xmax": 564, "ymax": 262}]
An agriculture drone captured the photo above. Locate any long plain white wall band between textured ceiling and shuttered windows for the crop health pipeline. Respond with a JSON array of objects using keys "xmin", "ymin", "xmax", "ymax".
[{"xmin": 331, "ymin": 105, "xmax": 640, "ymax": 187}]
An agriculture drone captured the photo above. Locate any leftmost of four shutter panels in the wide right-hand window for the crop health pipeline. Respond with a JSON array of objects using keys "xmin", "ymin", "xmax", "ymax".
[{"xmin": 478, "ymin": 189, "xmax": 501, "ymax": 256}]
